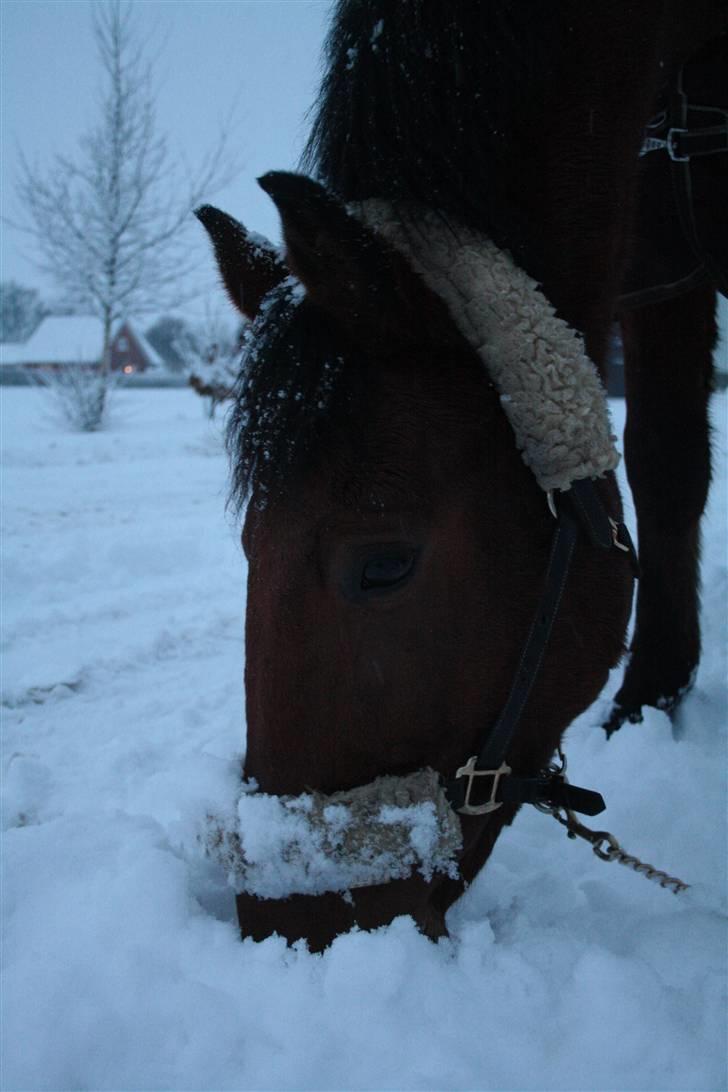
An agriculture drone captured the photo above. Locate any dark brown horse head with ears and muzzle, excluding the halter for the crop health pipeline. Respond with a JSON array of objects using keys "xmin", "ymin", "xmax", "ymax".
[{"xmin": 200, "ymin": 174, "xmax": 631, "ymax": 947}]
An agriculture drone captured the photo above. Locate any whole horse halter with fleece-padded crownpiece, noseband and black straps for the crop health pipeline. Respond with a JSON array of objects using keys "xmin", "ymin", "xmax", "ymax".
[{"xmin": 202, "ymin": 208, "xmax": 636, "ymax": 899}]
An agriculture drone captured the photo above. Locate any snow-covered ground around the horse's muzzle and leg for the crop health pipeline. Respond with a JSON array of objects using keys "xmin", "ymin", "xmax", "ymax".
[{"xmin": 0, "ymin": 371, "xmax": 728, "ymax": 1092}]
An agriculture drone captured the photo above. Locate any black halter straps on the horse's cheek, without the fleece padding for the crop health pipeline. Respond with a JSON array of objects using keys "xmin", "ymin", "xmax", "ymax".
[{"xmin": 445, "ymin": 480, "xmax": 637, "ymax": 816}]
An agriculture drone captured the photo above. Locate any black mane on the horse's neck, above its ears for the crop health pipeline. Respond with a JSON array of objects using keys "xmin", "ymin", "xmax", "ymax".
[{"xmin": 301, "ymin": 0, "xmax": 559, "ymax": 268}]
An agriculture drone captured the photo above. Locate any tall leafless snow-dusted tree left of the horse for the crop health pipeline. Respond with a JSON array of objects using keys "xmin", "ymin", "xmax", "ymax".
[{"xmin": 16, "ymin": 0, "xmax": 235, "ymax": 423}]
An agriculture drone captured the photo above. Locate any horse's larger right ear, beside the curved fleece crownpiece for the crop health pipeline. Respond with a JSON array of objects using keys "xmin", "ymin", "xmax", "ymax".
[{"xmin": 258, "ymin": 171, "xmax": 447, "ymax": 341}]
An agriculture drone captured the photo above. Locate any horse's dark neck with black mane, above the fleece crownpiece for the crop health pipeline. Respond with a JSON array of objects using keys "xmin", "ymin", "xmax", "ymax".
[{"xmin": 305, "ymin": 0, "xmax": 711, "ymax": 368}]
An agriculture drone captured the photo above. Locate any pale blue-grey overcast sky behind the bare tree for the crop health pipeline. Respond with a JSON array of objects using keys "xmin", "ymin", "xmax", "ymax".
[{"xmin": 0, "ymin": 0, "xmax": 331, "ymax": 317}]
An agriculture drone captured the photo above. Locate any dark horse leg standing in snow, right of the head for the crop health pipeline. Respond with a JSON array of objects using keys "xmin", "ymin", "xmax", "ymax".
[{"xmin": 606, "ymin": 285, "xmax": 717, "ymax": 735}]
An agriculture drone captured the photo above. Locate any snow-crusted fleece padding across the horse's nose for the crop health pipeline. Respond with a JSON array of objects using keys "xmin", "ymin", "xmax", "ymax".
[{"xmin": 201, "ymin": 769, "xmax": 462, "ymax": 899}]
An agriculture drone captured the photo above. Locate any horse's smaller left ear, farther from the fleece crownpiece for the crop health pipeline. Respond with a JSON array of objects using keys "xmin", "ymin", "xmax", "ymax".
[{"xmin": 194, "ymin": 205, "xmax": 288, "ymax": 319}]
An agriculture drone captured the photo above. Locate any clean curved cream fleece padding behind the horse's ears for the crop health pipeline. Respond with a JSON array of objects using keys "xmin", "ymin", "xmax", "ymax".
[{"xmin": 350, "ymin": 200, "xmax": 619, "ymax": 491}]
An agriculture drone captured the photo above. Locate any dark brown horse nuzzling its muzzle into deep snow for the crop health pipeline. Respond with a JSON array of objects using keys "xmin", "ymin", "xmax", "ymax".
[{"xmin": 198, "ymin": 0, "xmax": 725, "ymax": 950}]
